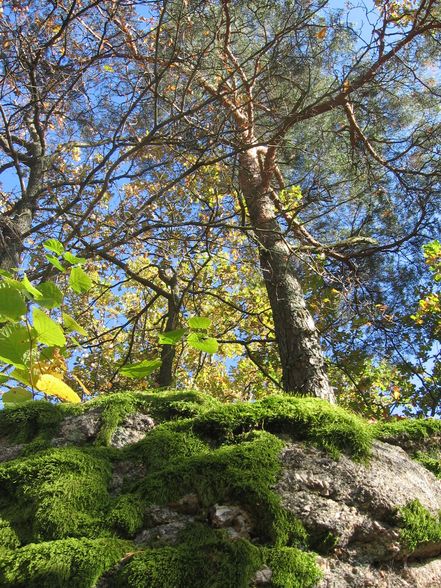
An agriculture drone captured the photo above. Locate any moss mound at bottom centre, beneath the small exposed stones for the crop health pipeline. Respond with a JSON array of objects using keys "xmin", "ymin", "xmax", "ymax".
[{"xmin": 110, "ymin": 525, "xmax": 320, "ymax": 588}]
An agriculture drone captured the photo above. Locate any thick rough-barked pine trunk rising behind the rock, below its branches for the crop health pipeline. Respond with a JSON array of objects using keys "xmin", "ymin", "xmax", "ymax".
[{"xmin": 239, "ymin": 148, "xmax": 335, "ymax": 402}]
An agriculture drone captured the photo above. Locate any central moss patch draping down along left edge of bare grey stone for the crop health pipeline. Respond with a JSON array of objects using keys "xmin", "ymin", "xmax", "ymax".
[{"xmin": 138, "ymin": 431, "xmax": 306, "ymax": 545}]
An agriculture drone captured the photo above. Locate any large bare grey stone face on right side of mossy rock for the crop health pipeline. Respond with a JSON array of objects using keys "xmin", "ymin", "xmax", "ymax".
[{"xmin": 276, "ymin": 442, "xmax": 441, "ymax": 588}]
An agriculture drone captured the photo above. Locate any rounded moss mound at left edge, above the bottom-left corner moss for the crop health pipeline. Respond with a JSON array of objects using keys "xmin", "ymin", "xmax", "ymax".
[{"xmin": 0, "ymin": 447, "xmax": 110, "ymax": 542}]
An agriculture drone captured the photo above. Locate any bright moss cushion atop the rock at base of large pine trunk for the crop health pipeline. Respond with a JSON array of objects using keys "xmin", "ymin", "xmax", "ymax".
[{"xmin": 193, "ymin": 396, "xmax": 373, "ymax": 459}]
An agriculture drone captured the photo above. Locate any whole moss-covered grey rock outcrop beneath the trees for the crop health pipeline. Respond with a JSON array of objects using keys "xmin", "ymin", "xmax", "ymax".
[{"xmin": 0, "ymin": 392, "xmax": 441, "ymax": 588}]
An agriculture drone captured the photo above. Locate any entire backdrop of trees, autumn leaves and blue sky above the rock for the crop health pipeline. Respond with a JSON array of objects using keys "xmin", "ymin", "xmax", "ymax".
[{"xmin": 0, "ymin": 0, "xmax": 441, "ymax": 417}]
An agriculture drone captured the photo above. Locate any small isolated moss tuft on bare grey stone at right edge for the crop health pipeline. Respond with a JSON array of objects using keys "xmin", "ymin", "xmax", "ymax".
[{"xmin": 398, "ymin": 500, "xmax": 441, "ymax": 552}]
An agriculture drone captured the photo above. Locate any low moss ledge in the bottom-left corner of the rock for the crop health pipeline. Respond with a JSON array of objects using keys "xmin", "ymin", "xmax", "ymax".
[{"xmin": 0, "ymin": 539, "xmax": 130, "ymax": 588}]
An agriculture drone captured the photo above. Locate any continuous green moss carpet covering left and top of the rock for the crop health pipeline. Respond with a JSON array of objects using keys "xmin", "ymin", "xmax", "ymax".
[{"xmin": 0, "ymin": 391, "xmax": 436, "ymax": 588}]
